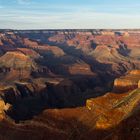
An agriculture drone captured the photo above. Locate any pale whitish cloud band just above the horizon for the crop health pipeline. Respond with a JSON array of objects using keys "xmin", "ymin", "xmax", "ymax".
[{"xmin": 0, "ymin": 11, "xmax": 140, "ymax": 29}]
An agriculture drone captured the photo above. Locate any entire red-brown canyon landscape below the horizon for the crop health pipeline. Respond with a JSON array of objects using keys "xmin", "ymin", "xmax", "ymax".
[{"xmin": 0, "ymin": 29, "xmax": 140, "ymax": 140}]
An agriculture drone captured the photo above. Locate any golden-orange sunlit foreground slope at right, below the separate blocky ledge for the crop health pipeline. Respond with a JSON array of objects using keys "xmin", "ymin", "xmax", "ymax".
[{"xmin": 86, "ymin": 89, "xmax": 140, "ymax": 129}]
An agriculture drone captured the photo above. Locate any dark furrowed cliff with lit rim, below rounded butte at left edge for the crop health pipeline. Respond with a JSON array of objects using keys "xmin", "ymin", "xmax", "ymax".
[{"xmin": 0, "ymin": 82, "xmax": 46, "ymax": 104}]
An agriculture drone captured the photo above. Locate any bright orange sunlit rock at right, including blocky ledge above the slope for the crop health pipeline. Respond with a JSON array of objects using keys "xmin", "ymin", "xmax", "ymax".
[{"xmin": 86, "ymin": 70, "xmax": 140, "ymax": 130}]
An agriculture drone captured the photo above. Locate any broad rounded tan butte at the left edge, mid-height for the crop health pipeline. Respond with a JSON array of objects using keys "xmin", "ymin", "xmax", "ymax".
[{"xmin": 0, "ymin": 51, "xmax": 37, "ymax": 83}]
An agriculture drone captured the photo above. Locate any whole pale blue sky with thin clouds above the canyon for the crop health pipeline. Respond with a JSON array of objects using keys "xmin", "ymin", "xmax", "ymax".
[{"xmin": 0, "ymin": 0, "xmax": 140, "ymax": 29}]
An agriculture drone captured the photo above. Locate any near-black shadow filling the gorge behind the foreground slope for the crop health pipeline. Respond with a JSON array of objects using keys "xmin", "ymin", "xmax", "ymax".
[{"xmin": 3, "ymin": 76, "xmax": 115, "ymax": 123}]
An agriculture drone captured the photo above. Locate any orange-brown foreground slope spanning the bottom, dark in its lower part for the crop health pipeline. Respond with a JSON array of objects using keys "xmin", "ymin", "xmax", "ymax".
[{"xmin": 0, "ymin": 71, "xmax": 140, "ymax": 140}]
